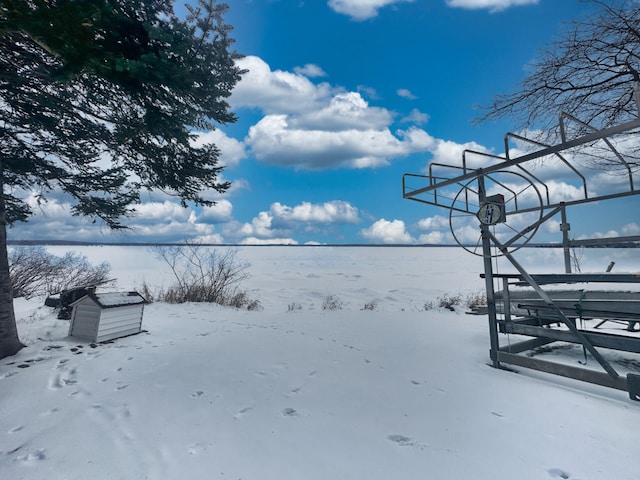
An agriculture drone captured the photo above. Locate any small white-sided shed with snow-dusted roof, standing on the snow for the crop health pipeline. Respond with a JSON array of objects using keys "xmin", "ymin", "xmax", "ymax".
[{"xmin": 69, "ymin": 292, "xmax": 147, "ymax": 342}]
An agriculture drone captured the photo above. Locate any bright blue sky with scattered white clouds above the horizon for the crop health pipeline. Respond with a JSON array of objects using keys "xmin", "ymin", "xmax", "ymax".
[{"xmin": 9, "ymin": 0, "xmax": 640, "ymax": 244}]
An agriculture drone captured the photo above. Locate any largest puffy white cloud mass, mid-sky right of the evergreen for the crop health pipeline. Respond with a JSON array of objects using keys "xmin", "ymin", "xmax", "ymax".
[{"xmin": 231, "ymin": 57, "xmax": 434, "ymax": 169}]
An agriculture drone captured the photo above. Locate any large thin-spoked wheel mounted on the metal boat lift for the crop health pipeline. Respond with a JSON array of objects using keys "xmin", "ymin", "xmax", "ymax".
[{"xmin": 449, "ymin": 170, "xmax": 544, "ymax": 257}]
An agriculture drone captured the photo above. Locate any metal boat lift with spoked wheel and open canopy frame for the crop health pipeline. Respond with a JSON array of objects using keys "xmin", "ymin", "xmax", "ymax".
[{"xmin": 402, "ymin": 110, "xmax": 640, "ymax": 401}]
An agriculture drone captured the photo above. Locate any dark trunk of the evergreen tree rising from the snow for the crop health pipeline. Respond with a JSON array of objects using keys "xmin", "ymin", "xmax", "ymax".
[{"xmin": 0, "ymin": 170, "xmax": 24, "ymax": 358}]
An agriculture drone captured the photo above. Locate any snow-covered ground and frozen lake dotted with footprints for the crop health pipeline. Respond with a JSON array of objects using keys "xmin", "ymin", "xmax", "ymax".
[{"xmin": 0, "ymin": 246, "xmax": 640, "ymax": 480}]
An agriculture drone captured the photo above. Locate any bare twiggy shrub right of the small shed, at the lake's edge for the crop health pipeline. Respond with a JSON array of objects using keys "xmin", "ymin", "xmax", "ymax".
[{"xmin": 151, "ymin": 241, "xmax": 261, "ymax": 310}]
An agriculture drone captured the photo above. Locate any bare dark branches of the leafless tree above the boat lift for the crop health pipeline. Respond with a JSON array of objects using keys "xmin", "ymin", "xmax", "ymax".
[{"xmin": 476, "ymin": 0, "xmax": 640, "ymax": 139}]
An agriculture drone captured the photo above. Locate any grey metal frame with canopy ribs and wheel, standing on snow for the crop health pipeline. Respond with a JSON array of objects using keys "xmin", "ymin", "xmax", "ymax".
[{"xmin": 402, "ymin": 114, "xmax": 640, "ymax": 401}]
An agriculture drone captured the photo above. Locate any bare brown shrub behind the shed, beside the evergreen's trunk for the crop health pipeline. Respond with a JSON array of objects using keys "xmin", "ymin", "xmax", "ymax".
[{"xmin": 9, "ymin": 245, "xmax": 111, "ymax": 299}]
